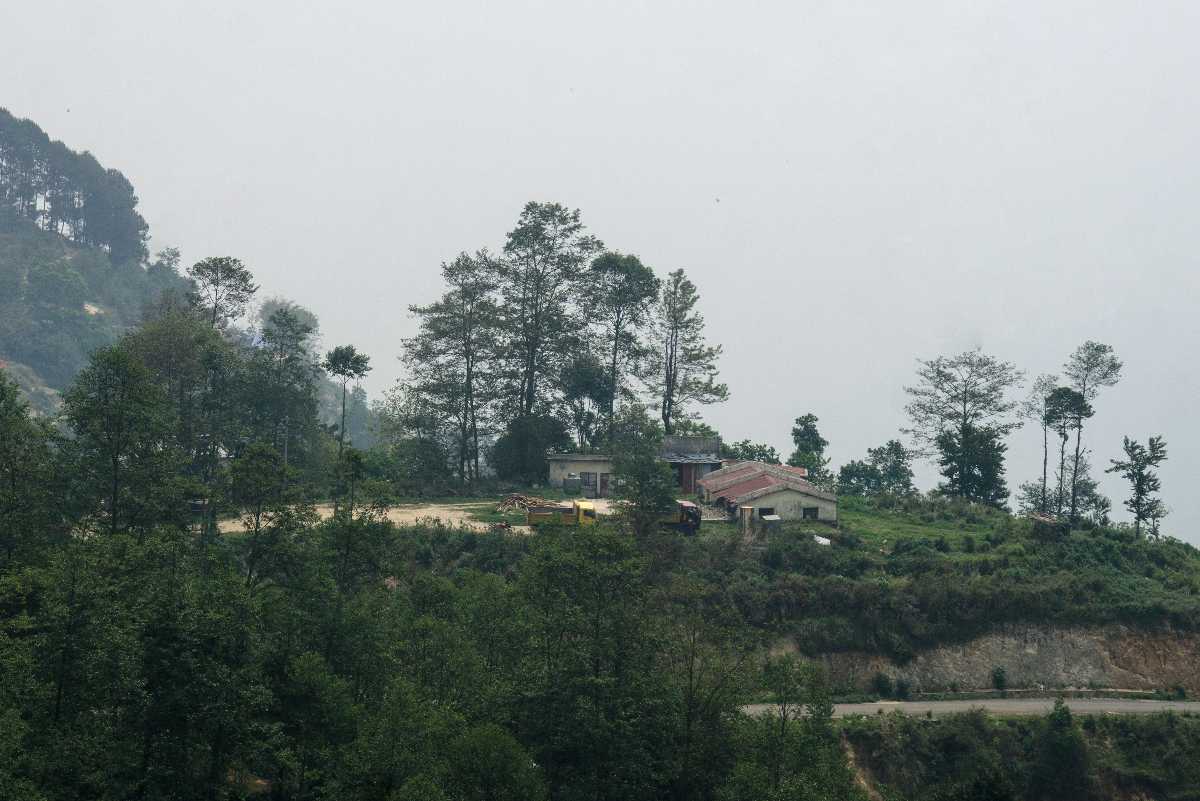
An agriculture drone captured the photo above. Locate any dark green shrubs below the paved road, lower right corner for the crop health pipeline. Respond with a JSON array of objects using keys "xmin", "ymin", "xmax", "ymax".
[{"xmin": 842, "ymin": 705, "xmax": 1200, "ymax": 801}]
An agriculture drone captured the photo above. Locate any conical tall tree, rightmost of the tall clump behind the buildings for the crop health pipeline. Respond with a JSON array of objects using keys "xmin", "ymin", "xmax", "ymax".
[{"xmin": 649, "ymin": 270, "xmax": 730, "ymax": 434}]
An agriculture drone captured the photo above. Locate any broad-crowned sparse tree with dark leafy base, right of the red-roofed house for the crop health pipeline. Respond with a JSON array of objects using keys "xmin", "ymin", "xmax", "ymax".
[{"xmin": 905, "ymin": 350, "xmax": 1022, "ymax": 502}]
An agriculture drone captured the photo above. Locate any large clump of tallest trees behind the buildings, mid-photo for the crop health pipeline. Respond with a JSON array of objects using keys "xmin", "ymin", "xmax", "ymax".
[{"xmin": 379, "ymin": 203, "xmax": 728, "ymax": 484}]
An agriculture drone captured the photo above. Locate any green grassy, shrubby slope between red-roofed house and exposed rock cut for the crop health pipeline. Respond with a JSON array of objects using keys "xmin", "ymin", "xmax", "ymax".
[{"xmin": 689, "ymin": 499, "xmax": 1200, "ymax": 660}]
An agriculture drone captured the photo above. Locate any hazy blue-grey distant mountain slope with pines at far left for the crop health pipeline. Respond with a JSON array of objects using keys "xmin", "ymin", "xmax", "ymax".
[{"xmin": 0, "ymin": 109, "xmax": 187, "ymax": 411}]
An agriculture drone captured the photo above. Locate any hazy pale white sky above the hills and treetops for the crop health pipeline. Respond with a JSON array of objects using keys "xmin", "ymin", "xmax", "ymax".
[{"xmin": 0, "ymin": 0, "xmax": 1200, "ymax": 542}]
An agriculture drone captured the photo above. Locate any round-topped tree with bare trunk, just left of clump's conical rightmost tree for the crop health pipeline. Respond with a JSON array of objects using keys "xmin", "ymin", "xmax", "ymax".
[{"xmin": 588, "ymin": 252, "xmax": 659, "ymax": 439}]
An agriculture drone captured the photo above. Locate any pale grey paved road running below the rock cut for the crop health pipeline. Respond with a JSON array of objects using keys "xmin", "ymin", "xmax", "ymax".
[{"xmin": 742, "ymin": 698, "xmax": 1200, "ymax": 717}]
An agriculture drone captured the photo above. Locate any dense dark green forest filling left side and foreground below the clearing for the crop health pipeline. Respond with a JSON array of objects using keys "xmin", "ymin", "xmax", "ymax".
[{"xmin": 0, "ymin": 321, "xmax": 854, "ymax": 800}]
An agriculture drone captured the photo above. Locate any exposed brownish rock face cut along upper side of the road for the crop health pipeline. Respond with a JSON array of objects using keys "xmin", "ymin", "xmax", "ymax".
[{"xmin": 780, "ymin": 625, "xmax": 1200, "ymax": 695}]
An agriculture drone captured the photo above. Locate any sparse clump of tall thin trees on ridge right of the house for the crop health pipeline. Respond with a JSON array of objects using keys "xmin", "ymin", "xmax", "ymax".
[{"xmin": 892, "ymin": 341, "xmax": 1166, "ymax": 535}]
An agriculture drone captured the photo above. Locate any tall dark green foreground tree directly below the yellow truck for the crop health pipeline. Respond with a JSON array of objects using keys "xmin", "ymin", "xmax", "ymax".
[{"xmin": 516, "ymin": 526, "xmax": 670, "ymax": 799}]
